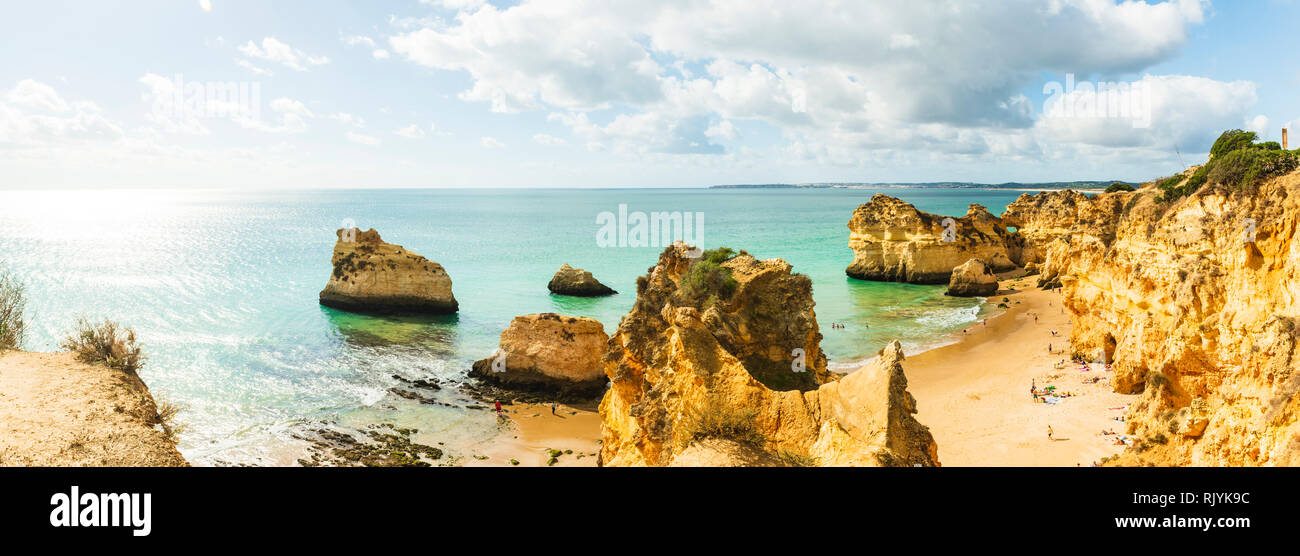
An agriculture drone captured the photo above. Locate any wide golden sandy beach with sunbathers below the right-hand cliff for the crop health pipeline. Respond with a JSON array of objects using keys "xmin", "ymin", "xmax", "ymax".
[{"xmin": 904, "ymin": 277, "xmax": 1134, "ymax": 466}]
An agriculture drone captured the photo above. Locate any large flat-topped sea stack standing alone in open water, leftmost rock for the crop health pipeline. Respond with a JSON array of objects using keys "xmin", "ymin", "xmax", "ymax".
[{"xmin": 320, "ymin": 227, "xmax": 459, "ymax": 314}]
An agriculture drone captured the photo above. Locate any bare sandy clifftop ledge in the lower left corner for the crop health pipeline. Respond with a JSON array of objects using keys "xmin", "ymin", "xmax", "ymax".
[{"xmin": 0, "ymin": 351, "xmax": 186, "ymax": 466}]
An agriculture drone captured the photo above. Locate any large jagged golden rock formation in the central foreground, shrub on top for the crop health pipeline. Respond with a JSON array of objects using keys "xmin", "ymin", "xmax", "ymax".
[{"xmin": 601, "ymin": 247, "xmax": 937, "ymax": 466}]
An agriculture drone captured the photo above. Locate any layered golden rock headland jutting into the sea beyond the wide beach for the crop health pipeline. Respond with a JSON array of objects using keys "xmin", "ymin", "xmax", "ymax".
[{"xmin": 845, "ymin": 194, "xmax": 1021, "ymax": 283}]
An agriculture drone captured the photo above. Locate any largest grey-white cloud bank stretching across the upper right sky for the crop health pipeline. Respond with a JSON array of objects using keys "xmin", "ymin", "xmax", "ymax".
[{"xmin": 387, "ymin": 0, "xmax": 1227, "ymax": 165}]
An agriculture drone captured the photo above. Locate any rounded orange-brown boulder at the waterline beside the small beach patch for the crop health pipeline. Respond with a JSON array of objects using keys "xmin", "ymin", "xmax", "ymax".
[{"xmin": 469, "ymin": 313, "xmax": 610, "ymax": 400}]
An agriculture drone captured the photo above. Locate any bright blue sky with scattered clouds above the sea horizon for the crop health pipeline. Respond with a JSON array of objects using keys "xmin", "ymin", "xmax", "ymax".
[{"xmin": 0, "ymin": 0, "xmax": 1300, "ymax": 190}]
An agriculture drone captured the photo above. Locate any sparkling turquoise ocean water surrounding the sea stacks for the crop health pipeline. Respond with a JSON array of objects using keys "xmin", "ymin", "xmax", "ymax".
[{"xmin": 0, "ymin": 188, "xmax": 1019, "ymax": 465}]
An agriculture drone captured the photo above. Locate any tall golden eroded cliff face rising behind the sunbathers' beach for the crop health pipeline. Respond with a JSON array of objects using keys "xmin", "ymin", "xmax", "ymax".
[{"xmin": 1026, "ymin": 173, "xmax": 1300, "ymax": 465}]
